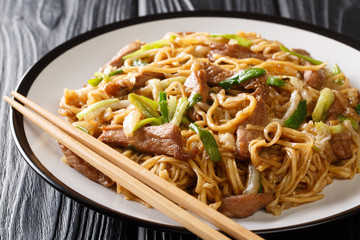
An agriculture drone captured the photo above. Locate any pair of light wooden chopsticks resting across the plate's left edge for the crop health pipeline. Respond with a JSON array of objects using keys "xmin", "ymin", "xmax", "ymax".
[{"xmin": 4, "ymin": 91, "xmax": 263, "ymax": 240}]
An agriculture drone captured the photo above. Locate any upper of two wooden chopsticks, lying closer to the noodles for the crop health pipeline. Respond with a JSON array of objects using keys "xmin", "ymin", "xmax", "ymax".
[{"xmin": 8, "ymin": 91, "xmax": 262, "ymax": 239}]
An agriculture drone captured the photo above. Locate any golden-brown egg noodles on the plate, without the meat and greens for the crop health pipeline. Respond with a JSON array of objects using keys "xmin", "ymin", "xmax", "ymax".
[{"xmin": 59, "ymin": 32, "xmax": 360, "ymax": 215}]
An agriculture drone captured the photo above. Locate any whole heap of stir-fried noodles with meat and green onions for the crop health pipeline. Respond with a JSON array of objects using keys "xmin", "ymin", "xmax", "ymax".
[{"xmin": 59, "ymin": 32, "xmax": 360, "ymax": 217}]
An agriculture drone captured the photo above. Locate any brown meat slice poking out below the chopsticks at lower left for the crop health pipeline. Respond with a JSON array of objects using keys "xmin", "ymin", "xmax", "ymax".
[{"xmin": 59, "ymin": 144, "xmax": 114, "ymax": 187}]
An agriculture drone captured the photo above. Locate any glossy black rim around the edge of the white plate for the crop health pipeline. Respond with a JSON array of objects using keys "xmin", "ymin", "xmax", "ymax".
[{"xmin": 10, "ymin": 11, "xmax": 360, "ymax": 234}]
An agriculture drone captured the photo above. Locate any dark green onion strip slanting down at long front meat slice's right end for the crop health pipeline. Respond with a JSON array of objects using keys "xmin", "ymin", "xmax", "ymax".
[{"xmin": 189, "ymin": 123, "xmax": 221, "ymax": 162}]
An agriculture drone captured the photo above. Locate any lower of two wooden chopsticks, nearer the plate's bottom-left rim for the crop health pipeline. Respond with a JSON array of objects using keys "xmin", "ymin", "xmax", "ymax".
[{"xmin": 4, "ymin": 94, "xmax": 229, "ymax": 240}]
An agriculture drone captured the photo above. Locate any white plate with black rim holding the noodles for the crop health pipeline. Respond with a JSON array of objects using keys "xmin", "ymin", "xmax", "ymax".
[{"xmin": 12, "ymin": 13, "xmax": 360, "ymax": 232}]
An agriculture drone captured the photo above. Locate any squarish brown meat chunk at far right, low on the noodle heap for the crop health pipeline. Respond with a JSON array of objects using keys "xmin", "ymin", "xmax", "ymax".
[{"xmin": 330, "ymin": 130, "xmax": 353, "ymax": 160}]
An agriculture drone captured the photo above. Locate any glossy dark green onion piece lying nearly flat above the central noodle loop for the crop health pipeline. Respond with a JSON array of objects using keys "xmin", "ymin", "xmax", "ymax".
[{"xmin": 219, "ymin": 68, "xmax": 266, "ymax": 90}]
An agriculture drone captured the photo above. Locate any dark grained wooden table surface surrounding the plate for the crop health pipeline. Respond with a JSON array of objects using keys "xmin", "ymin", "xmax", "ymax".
[{"xmin": 0, "ymin": 0, "xmax": 360, "ymax": 240}]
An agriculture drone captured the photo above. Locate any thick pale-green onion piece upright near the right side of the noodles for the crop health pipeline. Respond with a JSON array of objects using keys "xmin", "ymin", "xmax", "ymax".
[{"xmin": 312, "ymin": 88, "xmax": 335, "ymax": 122}]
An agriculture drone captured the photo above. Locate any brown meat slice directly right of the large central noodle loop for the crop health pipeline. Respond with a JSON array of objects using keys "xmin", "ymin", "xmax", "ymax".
[{"xmin": 236, "ymin": 97, "xmax": 268, "ymax": 160}]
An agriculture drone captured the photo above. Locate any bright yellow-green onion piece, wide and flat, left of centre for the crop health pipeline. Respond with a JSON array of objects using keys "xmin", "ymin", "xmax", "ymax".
[{"xmin": 128, "ymin": 93, "xmax": 160, "ymax": 118}]
